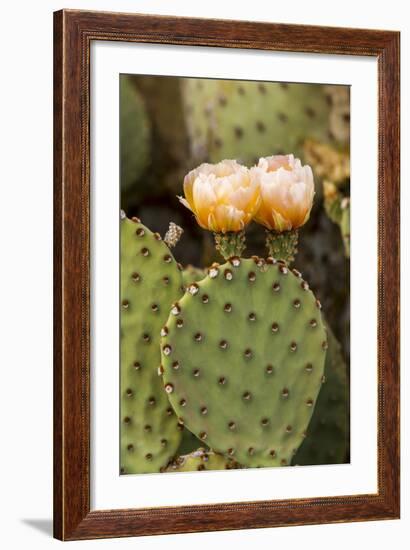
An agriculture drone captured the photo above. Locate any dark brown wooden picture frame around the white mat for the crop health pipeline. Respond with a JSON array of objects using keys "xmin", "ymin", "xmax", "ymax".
[{"xmin": 54, "ymin": 10, "xmax": 400, "ymax": 540}]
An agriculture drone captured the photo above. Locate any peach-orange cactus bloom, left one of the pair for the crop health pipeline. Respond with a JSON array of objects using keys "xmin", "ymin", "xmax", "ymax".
[{"xmin": 178, "ymin": 160, "xmax": 260, "ymax": 233}]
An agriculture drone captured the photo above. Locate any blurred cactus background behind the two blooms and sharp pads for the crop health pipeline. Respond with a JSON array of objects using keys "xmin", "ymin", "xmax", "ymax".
[{"xmin": 120, "ymin": 75, "xmax": 350, "ymax": 461}]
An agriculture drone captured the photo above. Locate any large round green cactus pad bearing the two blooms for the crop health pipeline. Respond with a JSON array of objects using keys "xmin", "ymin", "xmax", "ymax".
[{"xmin": 161, "ymin": 258, "xmax": 327, "ymax": 466}]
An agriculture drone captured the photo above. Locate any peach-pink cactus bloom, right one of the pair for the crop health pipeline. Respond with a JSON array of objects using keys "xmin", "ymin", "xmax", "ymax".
[{"xmin": 250, "ymin": 155, "xmax": 315, "ymax": 232}]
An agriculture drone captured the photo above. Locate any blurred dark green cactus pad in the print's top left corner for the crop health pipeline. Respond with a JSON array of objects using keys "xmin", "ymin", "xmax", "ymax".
[{"xmin": 120, "ymin": 77, "xmax": 151, "ymax": 192}]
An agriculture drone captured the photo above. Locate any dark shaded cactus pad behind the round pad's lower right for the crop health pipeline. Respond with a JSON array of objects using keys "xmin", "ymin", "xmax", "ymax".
[{"xmin": 292, "ymin": 325, "xmax": 349, "ymax": 466}]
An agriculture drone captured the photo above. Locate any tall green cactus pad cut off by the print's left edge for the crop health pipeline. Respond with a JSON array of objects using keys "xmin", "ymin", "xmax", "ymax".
[{"xmin": 121, "ymin": 215, "xmax": 183, "ymax": 474}]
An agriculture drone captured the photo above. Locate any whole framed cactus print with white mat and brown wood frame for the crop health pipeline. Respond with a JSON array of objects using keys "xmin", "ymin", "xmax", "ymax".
[{"xmin": 54, "ymin": 10, "xmax": 400, "ymax": 540}]
